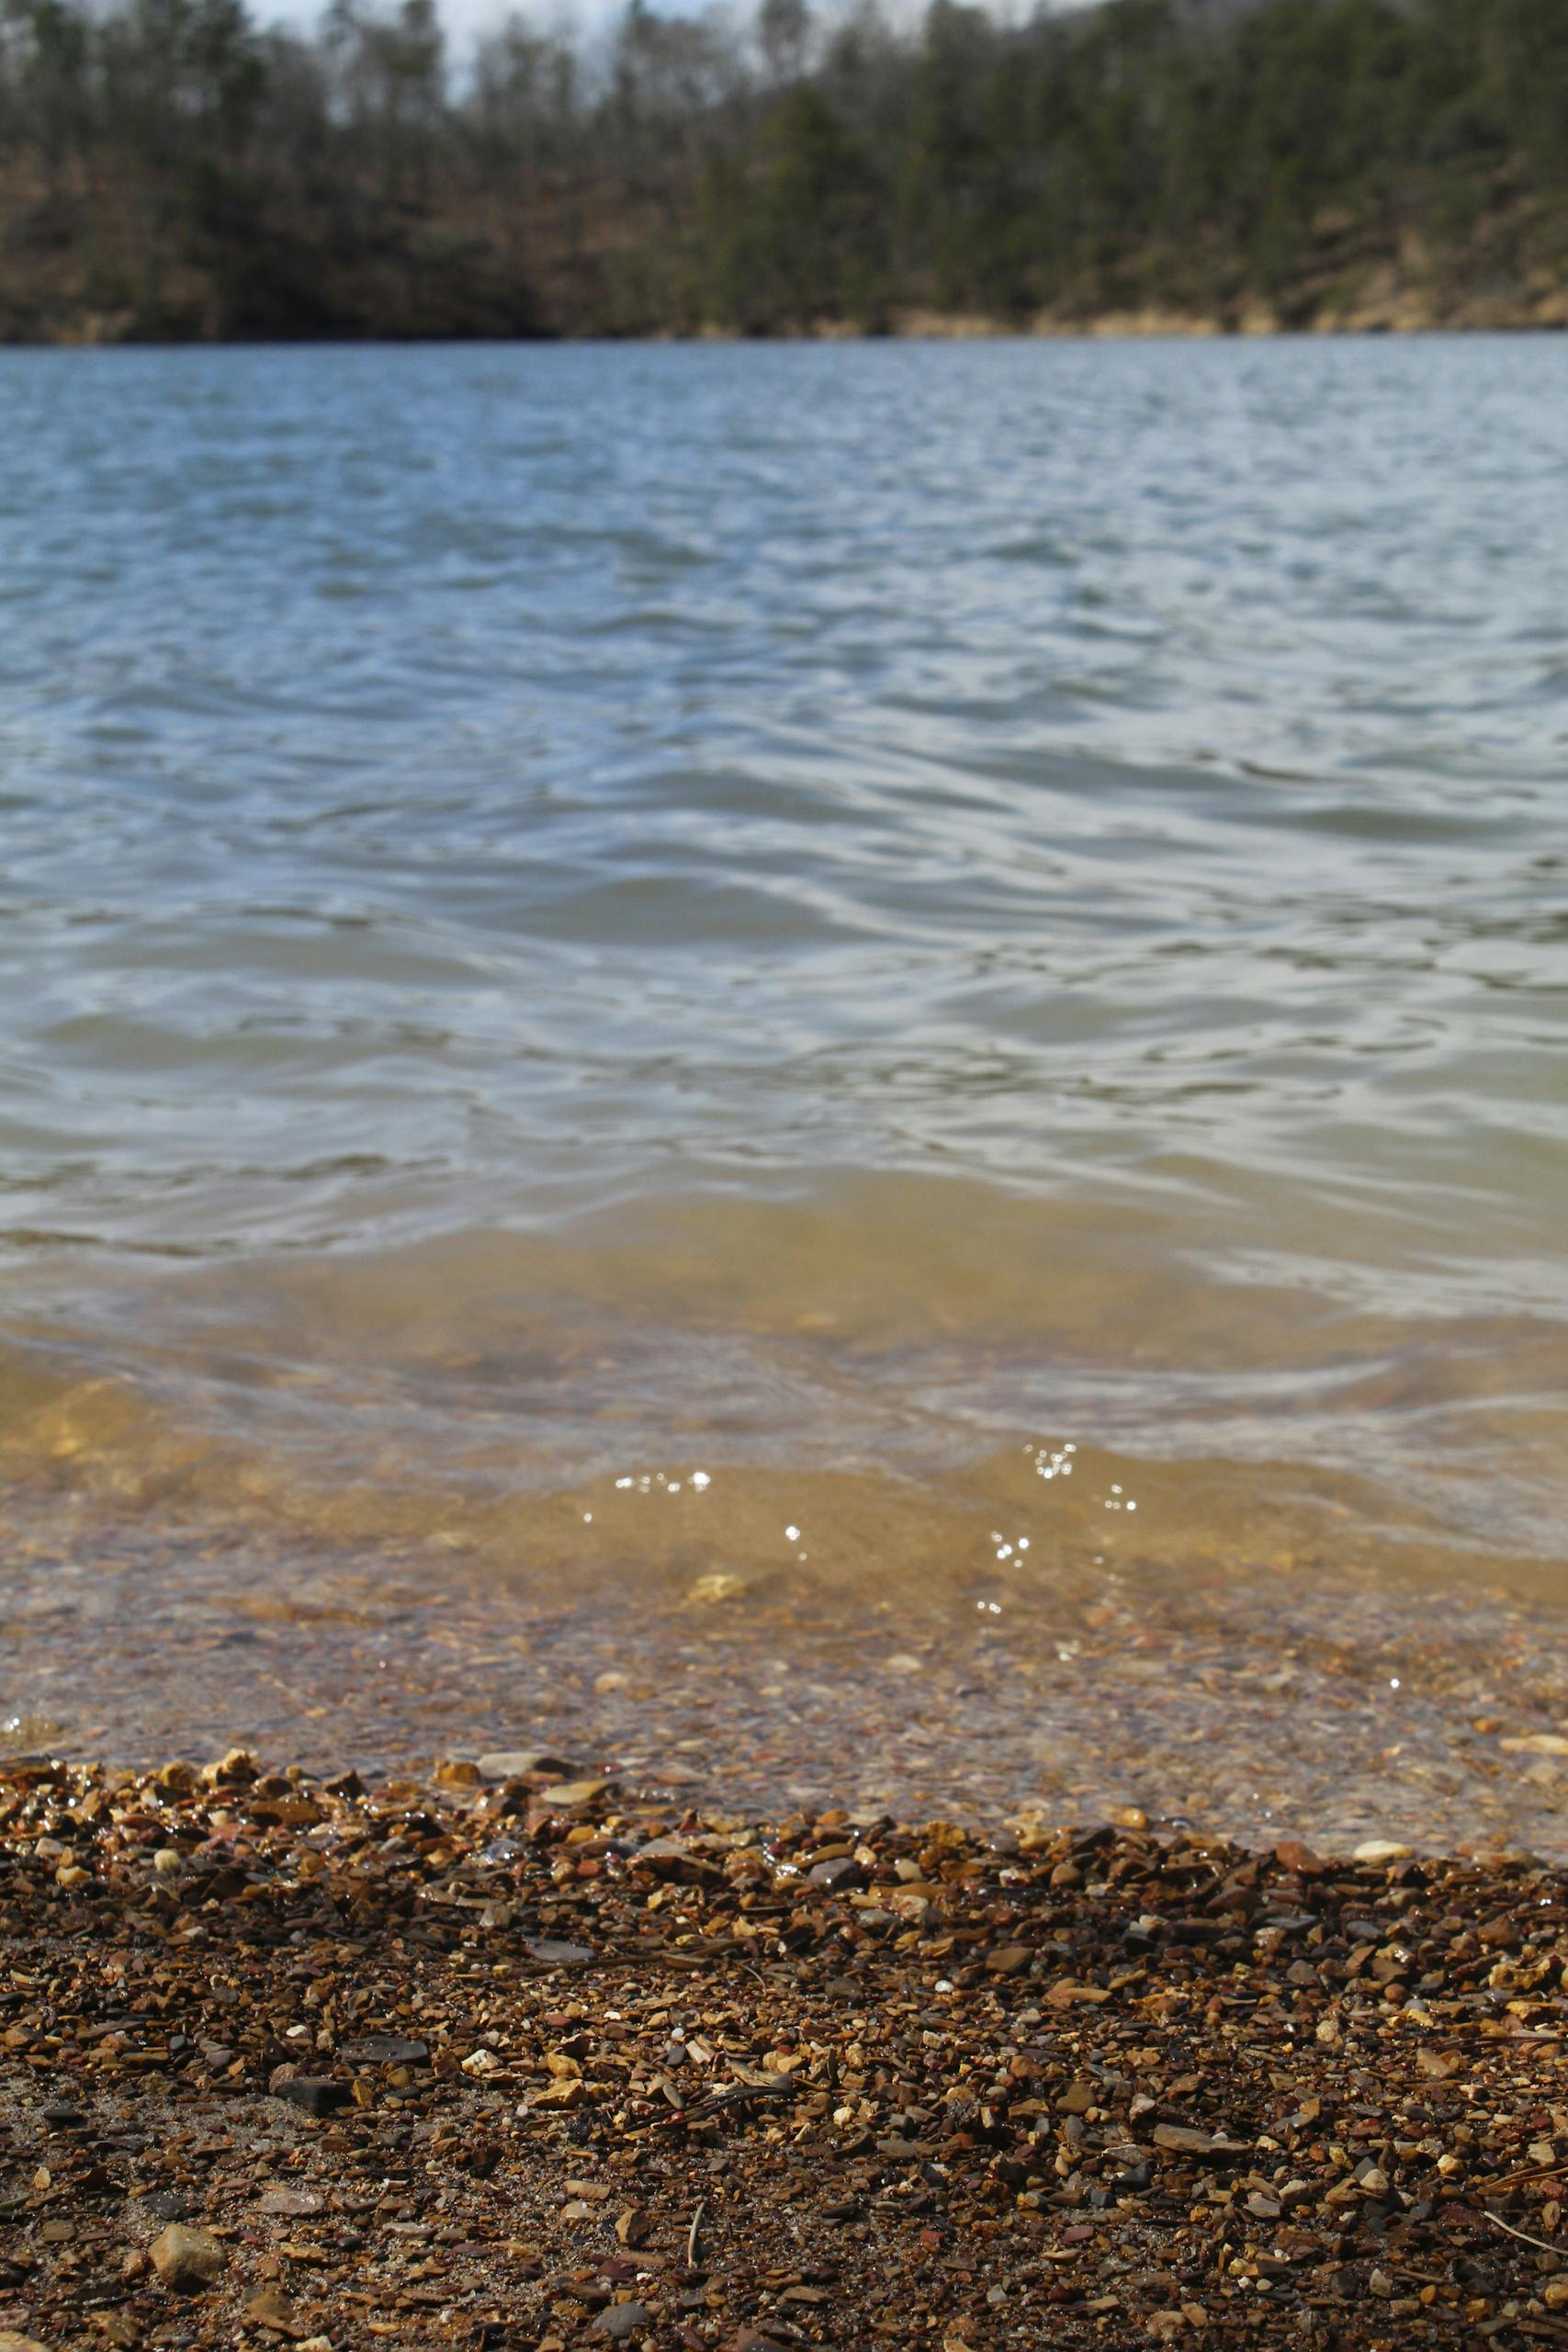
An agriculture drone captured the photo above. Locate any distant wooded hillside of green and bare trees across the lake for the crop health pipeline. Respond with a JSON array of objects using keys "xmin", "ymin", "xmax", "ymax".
[{"xmin": 0, "ymin": 0, "xmax": 1568, "ymax": 339}]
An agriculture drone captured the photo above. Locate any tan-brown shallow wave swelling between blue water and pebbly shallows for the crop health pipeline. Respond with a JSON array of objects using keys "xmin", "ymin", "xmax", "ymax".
[{"xmin": 0, "ymin": 1176, "xmax": 1568, "ymax": 1592}]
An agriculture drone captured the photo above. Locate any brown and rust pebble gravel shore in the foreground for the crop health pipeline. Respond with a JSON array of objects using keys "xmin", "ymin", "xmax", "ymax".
[{"xmin": 0, "ymin": 1752, "xmax": 1568, "ymax": 2352}]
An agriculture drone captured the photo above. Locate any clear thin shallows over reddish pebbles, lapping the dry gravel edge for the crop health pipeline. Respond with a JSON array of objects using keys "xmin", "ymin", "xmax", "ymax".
[{"xmin": 0, "ymin": 1458, "xmax": 1568, "ymax": 1856}]
